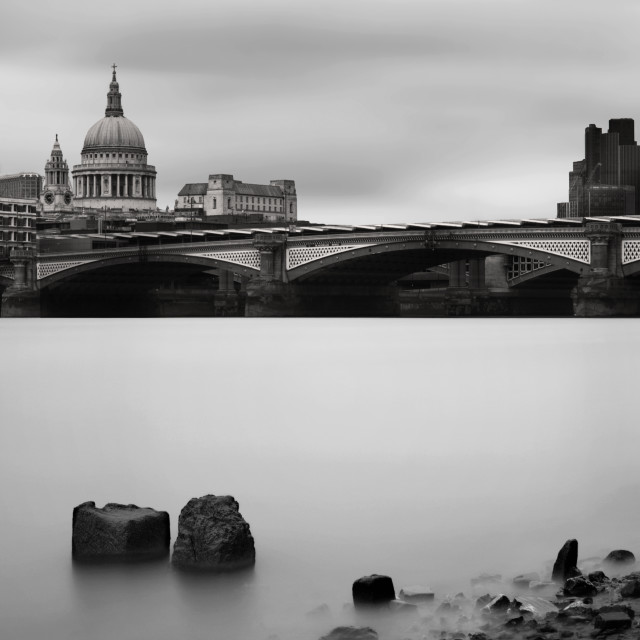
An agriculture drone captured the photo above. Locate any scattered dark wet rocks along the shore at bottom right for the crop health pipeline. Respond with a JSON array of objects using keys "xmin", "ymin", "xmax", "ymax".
[{"xmin": 320, "ymin": 540, "xmax": 640, "ymax": 640}]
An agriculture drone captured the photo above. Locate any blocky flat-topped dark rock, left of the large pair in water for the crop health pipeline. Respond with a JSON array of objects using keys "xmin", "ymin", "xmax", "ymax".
[{"xmin": 71, "ymin": 502, "xmax": 171, "ymax": 562}]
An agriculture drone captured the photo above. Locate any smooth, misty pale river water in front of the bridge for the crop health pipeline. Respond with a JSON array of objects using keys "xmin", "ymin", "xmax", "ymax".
[{"xmin": 0, "ymin": 319, "xmax": 640, "ymax": 640}]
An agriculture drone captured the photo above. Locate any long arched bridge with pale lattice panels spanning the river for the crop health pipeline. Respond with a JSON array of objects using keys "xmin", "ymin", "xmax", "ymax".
[{"xmin": 0, "ymin": 216, "xmax": 640, "ymax": 317}]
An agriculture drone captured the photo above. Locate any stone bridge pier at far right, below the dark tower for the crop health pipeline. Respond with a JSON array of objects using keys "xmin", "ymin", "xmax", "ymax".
[{"xmin": 571, "ymin": 222, "xmax": 640, "ymax": 318}]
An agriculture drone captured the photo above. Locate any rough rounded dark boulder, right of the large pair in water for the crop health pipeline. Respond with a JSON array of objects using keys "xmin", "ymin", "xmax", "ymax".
[{"xmin": 172, "ymin": 495, "xmax": 256, "ymax": 571}]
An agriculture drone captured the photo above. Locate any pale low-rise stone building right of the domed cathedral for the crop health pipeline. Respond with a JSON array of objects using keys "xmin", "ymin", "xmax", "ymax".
[{"xmin": 175, "ymin": 173, "xmax": 298, "ymax": 222}]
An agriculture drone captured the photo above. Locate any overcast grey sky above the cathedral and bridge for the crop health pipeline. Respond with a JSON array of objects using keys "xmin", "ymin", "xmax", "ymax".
[{"xmin": 0, "ymin": 0, "xmax": 640, "ymax": 223}]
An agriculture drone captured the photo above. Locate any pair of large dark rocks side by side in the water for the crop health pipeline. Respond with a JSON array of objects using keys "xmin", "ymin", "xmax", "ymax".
[{"xmin": 71, "ymin": 495, "xmax": 256, "ymax": 571}]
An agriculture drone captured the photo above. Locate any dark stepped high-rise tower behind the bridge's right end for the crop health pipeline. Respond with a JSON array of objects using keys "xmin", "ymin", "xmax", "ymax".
[{"xmin": 558, "ymin": 118, "xmax": 640, "ymax": 218}]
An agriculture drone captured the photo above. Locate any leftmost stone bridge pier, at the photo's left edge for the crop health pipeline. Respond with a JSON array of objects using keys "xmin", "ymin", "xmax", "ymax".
[{"xmin": 0, "ymin": 247, "xmax": 41, "ymax": 318}]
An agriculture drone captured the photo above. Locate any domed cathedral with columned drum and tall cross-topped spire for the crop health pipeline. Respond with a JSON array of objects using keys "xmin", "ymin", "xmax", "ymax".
[{"xmin": 71, "ymin": 65, "xmax": 156, "ymax": 213}]
